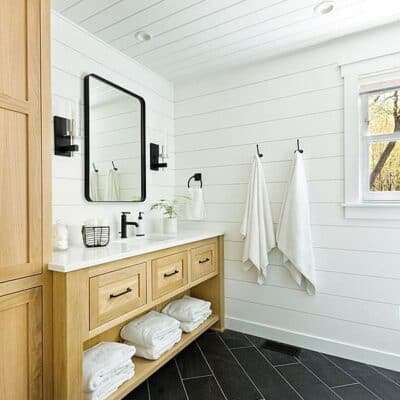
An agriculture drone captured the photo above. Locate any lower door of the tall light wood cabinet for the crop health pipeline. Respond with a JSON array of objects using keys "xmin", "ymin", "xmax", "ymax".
[{"xmin": 0, "ymin": 288, "xmax": 42, "ymax": 400}]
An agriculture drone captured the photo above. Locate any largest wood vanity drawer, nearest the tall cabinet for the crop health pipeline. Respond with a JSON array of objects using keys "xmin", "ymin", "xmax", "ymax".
[{"xmin": 90, "ymin": 263, "xmax": 146, "ymax": 329}]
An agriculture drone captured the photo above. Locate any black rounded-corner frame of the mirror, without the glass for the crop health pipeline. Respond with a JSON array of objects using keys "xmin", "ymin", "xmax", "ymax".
[{"xmin": 83, "ymin": 74, "xmax": 146, "ymax": 203}]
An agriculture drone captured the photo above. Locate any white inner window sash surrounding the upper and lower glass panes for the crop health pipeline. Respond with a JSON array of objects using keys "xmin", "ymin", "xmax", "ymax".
[{"xmin": 360, "ymin": 87, "xmax": 400, "ymax": 204}]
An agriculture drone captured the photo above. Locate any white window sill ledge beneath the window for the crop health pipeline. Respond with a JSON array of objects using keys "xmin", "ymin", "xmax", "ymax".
[{"xmin": 343, "ymin": 203, "xmax": 400, "ymax": 220}]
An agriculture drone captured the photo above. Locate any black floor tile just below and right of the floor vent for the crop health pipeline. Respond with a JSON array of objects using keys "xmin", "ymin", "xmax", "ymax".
[{"xmin": 297, "ymin": 350, "xmax": 355, "ymax": 387}]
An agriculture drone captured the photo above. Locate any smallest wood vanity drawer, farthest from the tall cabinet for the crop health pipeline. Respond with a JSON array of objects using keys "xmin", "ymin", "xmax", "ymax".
[{"xmin": 190, "ymin": 242, "xmax": 217, "ymax": 282}]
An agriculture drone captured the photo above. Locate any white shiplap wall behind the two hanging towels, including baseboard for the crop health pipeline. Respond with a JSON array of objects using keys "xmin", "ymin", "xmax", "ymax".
[{"xmin": 175, "ymin": 26, "xmax": 400, "ymax": 370}]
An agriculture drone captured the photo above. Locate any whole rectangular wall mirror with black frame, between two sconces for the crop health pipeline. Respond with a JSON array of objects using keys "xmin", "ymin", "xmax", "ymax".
[{"xmin": 84, "ymin": 74, "xmax": 146, "ymax": 202}]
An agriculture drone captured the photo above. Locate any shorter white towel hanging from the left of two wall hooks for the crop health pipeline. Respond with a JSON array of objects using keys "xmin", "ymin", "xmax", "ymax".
[{"xmin": 240, "ymin": 156, "xmax": 276, "ymax": 285}]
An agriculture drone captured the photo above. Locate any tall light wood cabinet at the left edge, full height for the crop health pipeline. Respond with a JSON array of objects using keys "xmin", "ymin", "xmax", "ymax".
[{"xmin": 0, "ymin": 0, "xmax": 53, "ymax": 400}]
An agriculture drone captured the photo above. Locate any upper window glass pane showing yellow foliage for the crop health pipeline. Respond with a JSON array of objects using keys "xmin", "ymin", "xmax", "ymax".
[{"xmin": 368, "ymin": 88, "xmax": 400, "ymax": 135}]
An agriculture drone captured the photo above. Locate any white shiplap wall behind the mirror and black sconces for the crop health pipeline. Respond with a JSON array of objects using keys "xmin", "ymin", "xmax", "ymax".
[{"xmin": 52, "ymin": 12, "xmax": 175, "ymax": 240}]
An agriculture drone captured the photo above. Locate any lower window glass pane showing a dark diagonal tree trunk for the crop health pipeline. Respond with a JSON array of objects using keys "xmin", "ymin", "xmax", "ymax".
[{"xmin": 369, "ymin": 141, "xmax": 400, "ymax": 192}]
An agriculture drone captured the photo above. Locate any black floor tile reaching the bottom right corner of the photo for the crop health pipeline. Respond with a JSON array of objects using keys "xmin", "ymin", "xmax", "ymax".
[{"xmin": 327, "ymin": 356, "xmax": 400, "ymax": 400}]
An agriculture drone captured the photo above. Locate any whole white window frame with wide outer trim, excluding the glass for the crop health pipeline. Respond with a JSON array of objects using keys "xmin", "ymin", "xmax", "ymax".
[{"xmin": 340, "ymin": 53, "xmax": 400, "ymax": 220}]
